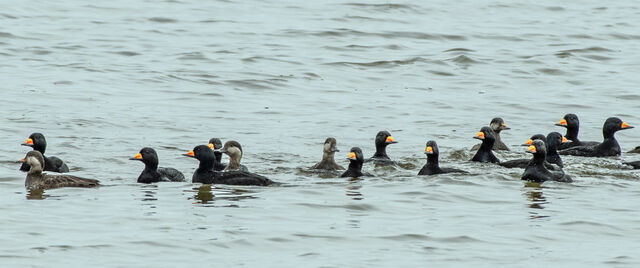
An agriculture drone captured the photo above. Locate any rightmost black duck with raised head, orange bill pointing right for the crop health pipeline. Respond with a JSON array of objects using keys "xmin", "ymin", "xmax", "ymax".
[{"xmin": 559, "ymin": 117, "xmax": 633, "ymax": 157}]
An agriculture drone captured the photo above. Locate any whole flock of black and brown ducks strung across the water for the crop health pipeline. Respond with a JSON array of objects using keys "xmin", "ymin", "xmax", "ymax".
[{"xmin": 15, "ymin": 114, "xmax": 640, "ymax": 189}]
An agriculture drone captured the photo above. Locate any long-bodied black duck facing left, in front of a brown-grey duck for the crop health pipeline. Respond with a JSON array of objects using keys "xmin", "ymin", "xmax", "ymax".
[{"xmin": 184, "ymin": 145, "xmax": 274, "ymax": 186}]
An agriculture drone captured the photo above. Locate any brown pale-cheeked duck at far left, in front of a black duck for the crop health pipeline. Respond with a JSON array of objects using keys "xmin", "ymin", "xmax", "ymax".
[{"xmin": 24, "ymin": 150, "xmax": 100, "ymax": 190}]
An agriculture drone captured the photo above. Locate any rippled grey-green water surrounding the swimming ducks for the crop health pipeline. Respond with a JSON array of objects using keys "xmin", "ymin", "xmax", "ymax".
[{"xmin": 0, "ymin": 0, "xmax": 640, "ymax": 267}]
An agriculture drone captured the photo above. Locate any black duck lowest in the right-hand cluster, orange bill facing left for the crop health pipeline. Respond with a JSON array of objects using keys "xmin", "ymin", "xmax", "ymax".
[{"xmin": 522, "ymin": 140, "xmax": 573, "ymax": 183}]
